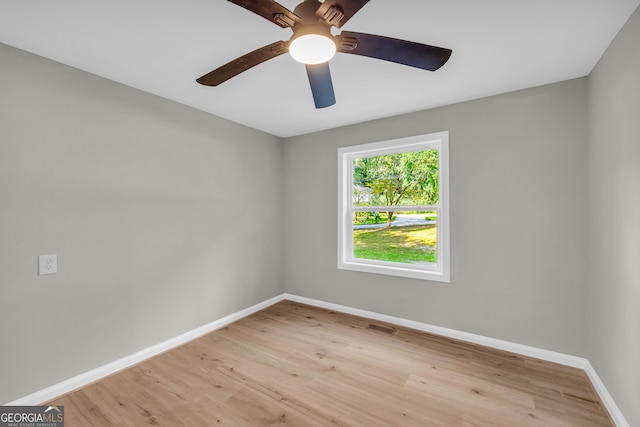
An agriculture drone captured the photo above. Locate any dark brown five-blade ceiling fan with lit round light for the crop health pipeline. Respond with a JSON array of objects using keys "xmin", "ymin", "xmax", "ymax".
[{"xmin": 196, "ymin": 0, "xmax": 451, "ymax": 108}]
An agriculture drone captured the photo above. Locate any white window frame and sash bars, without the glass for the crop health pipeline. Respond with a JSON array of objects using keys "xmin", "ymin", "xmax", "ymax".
[{"xmin": 338, "ymin": 131, "xmax": 450, "ymax": 283}]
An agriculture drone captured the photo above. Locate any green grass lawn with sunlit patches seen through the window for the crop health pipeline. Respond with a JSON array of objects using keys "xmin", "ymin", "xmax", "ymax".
[{"xmin": 353, "ymin": 224, "xmax": 437, "ymax": 264}]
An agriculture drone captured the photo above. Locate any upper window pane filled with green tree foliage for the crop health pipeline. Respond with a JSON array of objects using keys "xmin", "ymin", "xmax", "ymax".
[{"xmin": 352, "ymin": 149, "xmax": 438, "ymax": 206}]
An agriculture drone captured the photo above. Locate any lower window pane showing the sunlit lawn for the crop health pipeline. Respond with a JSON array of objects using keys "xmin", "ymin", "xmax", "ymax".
[{"xmin": 353, "ymin": 212, "xmax": 438, "ymax": 264}]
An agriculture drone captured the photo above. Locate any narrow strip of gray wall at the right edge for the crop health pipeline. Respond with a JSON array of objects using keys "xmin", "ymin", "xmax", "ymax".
[{"xmin": 588, "ymin": 5, "xmax": 640, "ymax": 426}]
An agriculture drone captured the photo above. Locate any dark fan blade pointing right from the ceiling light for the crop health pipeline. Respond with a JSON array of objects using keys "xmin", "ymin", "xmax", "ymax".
[{"xmin": 336, "ymin": 31, "xmax": 452, "ymax": 71}]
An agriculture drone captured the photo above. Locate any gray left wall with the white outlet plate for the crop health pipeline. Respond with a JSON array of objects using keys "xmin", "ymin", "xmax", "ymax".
[{"xmin": 0, "ymin": 44, "xmax": 283, "ymax": 403}]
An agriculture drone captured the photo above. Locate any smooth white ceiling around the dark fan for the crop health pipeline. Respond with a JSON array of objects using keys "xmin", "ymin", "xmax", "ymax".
[{"xmin": 0, "ymin": 0, "xmax": 640, "ymax": 137}]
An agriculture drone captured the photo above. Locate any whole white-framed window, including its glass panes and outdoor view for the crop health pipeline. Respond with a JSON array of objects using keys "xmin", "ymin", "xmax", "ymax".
[{"xmin": 338, "ymin": 132, "xmax": 449, "ymax": 282}]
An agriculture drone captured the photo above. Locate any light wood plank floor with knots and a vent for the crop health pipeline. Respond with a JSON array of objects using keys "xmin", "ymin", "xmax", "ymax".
[{"xmin": 49, "ymin": 301, "xmax": 614, "ymax": 427}]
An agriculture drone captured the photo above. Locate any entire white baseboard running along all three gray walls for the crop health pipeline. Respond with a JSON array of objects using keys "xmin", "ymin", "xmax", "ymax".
[{"xmin": 6, "ymin": 293, "xmax": 629, "ymax": 427}]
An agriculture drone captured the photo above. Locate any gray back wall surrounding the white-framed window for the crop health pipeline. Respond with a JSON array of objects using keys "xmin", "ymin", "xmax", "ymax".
[{"xmin": 284, "ymin": 78, "xmax": 589, "ymax": 356}]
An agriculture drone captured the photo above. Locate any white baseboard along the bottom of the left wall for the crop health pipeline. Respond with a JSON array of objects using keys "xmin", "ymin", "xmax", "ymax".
[{"xmin": 6, "ymin": 295, "xmax": 283, "ymax": 406}]
